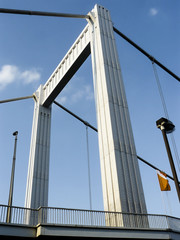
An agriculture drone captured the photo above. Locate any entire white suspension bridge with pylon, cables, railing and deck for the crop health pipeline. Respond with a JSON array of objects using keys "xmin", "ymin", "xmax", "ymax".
[{"xmin": 0, "ymin": 5, "xmax": 180, "ymax": 239}]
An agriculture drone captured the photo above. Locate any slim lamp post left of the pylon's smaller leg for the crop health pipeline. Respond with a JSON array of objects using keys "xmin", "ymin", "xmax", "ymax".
[{"xmin": 6, "ymin": 131, "xmax": 18, "ymax": 223}]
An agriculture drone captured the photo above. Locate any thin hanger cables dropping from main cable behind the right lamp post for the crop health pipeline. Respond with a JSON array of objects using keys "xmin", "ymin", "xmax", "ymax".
[{"xmin": 152, "ymin": 61, "xmax": 180, "ymax": 171}]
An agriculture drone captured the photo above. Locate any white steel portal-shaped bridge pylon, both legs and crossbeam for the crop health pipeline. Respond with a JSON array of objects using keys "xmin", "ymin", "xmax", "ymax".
[{"xmin": 25, "ymin": 5, "xmax": 146, "ymax": 219}]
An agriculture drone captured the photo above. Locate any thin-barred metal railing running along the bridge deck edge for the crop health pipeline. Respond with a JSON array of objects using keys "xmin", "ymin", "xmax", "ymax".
[{"xmin": 0, "ymin": 205, "xmax": 180, "ymax": 232}]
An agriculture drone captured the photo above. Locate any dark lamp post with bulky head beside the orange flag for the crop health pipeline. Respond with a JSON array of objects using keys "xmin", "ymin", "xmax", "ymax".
[{"xmin": 156, "ymin": 118, "xmax": 180, "ymax": 201}]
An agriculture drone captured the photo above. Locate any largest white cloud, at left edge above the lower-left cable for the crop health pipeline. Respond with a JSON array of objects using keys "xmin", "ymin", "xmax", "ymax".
[{"xmin": 0, "ymin": 65, "xmax": 41, "ymax": 90}]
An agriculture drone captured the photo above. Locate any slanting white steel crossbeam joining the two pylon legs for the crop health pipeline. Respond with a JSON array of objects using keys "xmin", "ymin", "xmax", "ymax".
[{"xmin": 42, "ymin": 25, "xmax": 90, "ymax": 106}]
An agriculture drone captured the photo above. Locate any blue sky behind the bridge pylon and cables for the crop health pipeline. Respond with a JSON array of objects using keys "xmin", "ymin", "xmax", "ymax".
[{"xmin": 0, "ymin": 0, "xmax": 180, "ymax": 216}]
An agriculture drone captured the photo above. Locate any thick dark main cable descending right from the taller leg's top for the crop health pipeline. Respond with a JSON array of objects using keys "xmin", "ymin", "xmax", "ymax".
[{"xmin": 113, "ymin": 27, "xmax": 180, "ymax": 82}]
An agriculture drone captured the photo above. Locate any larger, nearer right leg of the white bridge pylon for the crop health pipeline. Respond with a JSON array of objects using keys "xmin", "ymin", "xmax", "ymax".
[{"xmin": 90, "ymin": 5, "xmax": 146, "ymax": 218}]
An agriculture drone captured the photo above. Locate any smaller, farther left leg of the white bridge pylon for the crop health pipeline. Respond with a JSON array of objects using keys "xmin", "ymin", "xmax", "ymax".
[{"xmin": 25, "ymin": 85, "xmax": 51, "ymax": 208}]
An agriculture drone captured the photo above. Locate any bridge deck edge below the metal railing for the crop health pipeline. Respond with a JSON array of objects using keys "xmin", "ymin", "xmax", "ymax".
[{"xmin": 0, "ymin": 223, "xmax": 180, "ymax": 240}]
